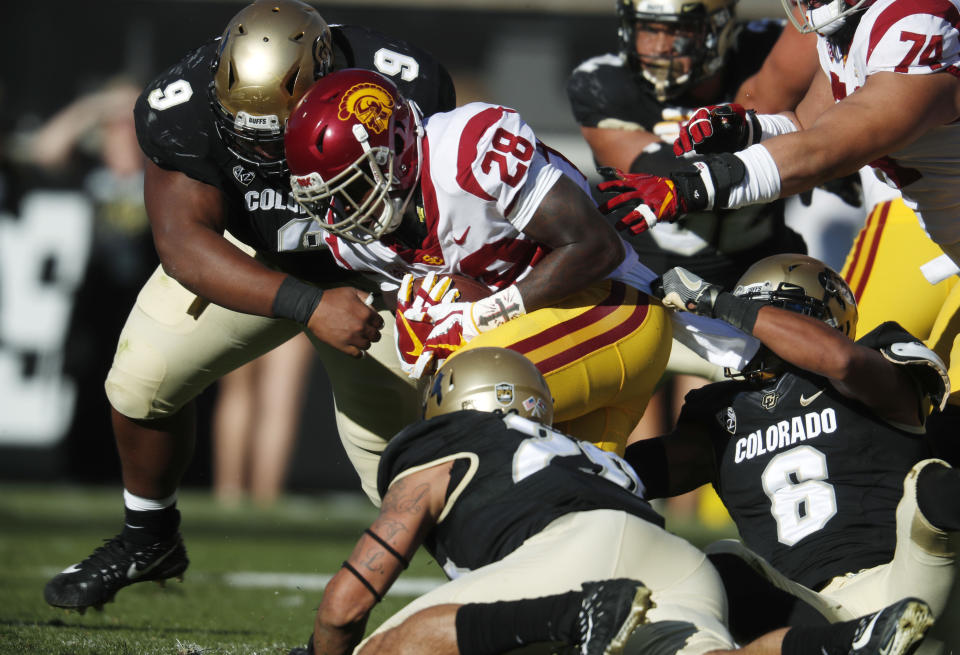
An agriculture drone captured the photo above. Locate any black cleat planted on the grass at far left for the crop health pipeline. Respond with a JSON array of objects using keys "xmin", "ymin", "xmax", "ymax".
[{"xmin": 43, "ymin": 533, "xmax": 190, "ymax": 613}]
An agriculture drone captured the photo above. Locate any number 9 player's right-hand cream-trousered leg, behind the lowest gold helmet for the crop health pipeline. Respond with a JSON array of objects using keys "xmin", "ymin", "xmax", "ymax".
[{"xmin": 314, "ymin": 294, "xmax": 426, "ymax": 506}]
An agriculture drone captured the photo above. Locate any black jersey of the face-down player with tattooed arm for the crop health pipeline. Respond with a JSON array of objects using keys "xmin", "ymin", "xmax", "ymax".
[{"xmin": 377, "ymin": 410, "xmax": 663, "ymax": 577}]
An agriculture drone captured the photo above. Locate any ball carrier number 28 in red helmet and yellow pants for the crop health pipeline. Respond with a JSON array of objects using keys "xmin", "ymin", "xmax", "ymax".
[{"xmin": 286, "ymin": 70, "xmax": 772, "ymax": 458}]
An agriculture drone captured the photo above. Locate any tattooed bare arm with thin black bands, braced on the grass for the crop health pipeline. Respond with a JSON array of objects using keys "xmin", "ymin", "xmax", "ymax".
[{"xmin": 313, "ymin": 462, "xmax": 453, "ymax": 655}]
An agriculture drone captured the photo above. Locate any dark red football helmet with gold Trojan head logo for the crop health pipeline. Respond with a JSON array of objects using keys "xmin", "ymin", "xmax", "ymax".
[{"xmin": 284, "ymin": 69, "xmax": 423, "ymax": 243}]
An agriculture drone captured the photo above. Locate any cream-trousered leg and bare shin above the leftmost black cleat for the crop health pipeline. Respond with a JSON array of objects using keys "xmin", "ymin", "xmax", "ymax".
[{"xmin": 104, "ymin": 267, "xmax": 300, "ymax": 498}]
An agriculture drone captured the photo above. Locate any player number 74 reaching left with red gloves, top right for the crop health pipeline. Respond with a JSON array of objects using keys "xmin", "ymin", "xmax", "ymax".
[{"xmin": 601, "ymin": 0, "xmax": 960, "ymax": 410}]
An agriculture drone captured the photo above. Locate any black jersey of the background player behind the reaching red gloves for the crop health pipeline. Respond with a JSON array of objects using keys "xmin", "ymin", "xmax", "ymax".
[{"xmin": 567, "ymin": 21, "xmax": 806, "ymax": 288}]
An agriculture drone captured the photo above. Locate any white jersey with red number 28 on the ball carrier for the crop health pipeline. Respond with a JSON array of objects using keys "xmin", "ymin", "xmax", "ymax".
[{"xmin": 325, "ymin": 102, "xmax": 590, "ymax": 290}]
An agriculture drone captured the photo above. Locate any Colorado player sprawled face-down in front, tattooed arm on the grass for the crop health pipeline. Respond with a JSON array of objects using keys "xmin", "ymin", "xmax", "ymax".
[{"xmin": 290, "ymin": 348, "xmax": 931, "ymax": 655}]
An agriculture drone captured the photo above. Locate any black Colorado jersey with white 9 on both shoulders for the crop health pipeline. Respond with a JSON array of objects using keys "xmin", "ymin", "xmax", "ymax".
[{"xmin": 134, "ymin": 25, "xmax": 456, "ymax": 281}]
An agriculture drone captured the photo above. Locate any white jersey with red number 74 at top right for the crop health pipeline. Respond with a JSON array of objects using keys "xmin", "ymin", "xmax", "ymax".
[{"xmin": 817, "ymin": 0, "xmax": 960, "ymax": 244}]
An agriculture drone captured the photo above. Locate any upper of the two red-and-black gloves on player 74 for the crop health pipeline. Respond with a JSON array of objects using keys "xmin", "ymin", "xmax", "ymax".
[{"xmin": 673, "ymin": 104, "xmax": 760, "ymax": 157}]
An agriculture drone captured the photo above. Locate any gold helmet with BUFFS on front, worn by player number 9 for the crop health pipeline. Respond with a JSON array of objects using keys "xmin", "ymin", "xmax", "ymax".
[{"xmin": 210, "ymin": 0, "xmax": 333, "ymax": 173}]
